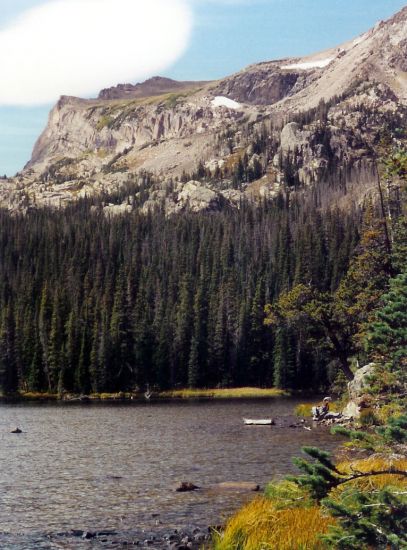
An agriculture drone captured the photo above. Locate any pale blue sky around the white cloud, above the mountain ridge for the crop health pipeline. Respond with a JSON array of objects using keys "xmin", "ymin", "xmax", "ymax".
[{"xmin": 0, "ymin": 0, "xmax": 405, "ymax": 175}]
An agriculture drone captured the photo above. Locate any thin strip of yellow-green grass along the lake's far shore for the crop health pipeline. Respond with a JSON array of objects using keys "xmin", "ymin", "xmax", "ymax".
[{"xmin": 159, "ymin": 388, "xmax": 288, "ymax": 399}]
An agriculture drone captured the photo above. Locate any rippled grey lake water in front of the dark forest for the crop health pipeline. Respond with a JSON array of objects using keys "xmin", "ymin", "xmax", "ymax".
[{"xmin": 0, "ymin": 398, "xmax": 338, "ymax": 548}]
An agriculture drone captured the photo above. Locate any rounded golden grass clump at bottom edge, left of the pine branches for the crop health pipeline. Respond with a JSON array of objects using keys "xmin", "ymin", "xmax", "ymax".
[{"xmin": 214, "ymin": 497, "xmax": 334, "ymax": 550}]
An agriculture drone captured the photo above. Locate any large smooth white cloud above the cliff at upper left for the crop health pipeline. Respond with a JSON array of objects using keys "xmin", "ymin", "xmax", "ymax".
[{"xmin": 0, "ymin": 0, "xmax": 192, "ymax": 105}]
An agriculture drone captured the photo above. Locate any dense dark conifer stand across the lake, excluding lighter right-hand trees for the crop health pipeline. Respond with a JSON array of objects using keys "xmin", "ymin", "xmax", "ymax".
[{"xmin": 0, "ymin": 185, "xmax": 361, "ymax": 393}]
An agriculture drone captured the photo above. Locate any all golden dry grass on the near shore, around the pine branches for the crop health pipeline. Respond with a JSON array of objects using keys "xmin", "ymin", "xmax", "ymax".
[{"xmin": 214, "ymin": 455, "xmax": 407, "ymax": 550}]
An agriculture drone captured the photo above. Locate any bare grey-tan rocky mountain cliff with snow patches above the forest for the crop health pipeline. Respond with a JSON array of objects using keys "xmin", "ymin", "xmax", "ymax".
[{"xmin": 0, "ymin": 8, "xmax": 407, "ymax": 213}]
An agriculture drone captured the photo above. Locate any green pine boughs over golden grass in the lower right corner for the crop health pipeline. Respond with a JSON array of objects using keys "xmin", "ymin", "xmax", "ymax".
[{"xmin": 288, "ymin": 415, "xmax": 407, "ymax": 550}]
